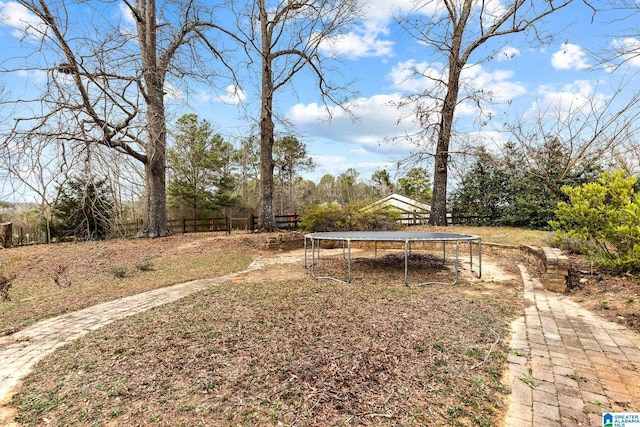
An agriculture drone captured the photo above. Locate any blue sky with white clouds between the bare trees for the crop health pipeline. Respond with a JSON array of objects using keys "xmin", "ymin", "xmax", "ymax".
[{"xmin": 0, "ymin": 0, "xmax": 640, "ymax": 186}]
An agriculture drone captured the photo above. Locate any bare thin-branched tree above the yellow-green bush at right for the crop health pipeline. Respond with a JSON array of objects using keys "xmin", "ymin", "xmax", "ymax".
[{"xmin": 507, "ymin": 81, "xmax": 640, "ymax": 181}]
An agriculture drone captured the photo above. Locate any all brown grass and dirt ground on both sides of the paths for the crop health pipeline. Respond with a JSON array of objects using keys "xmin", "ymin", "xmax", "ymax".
[{"xmin": 0, "ymin": 235, "xmax": 640, "ymax": 426}]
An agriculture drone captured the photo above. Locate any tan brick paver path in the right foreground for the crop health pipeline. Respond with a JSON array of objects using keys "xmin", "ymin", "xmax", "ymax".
[{"xmin": 505, "ymin": 267, "xmax": 640, "ymax": 427}]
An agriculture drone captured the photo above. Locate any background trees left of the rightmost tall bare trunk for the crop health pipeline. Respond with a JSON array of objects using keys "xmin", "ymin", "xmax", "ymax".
[{"xmin": 3, "ymin": 114, "xmax": 431, "ymax": 240}]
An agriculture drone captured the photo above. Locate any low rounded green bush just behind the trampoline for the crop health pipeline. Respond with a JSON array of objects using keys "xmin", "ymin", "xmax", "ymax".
[{"xmin": 300, "ymin": 203, "xmax": 400, "ymax": 232}]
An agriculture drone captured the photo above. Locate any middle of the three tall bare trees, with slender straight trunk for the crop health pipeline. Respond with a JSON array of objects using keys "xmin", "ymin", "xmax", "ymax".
[{"xmin": 235, "ymin": 0, "xmax": 359, "ymax": 231}]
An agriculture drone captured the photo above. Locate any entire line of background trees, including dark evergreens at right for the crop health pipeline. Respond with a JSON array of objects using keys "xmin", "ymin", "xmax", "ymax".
[{"xmin": 7, "ymin": 114, "xmax": 640, "ymax": 239}]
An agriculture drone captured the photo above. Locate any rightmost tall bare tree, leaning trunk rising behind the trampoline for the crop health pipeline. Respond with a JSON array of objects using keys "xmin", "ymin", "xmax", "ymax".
[{"xmin": 399, "ymin": 0, "xmax": 571, "ymax": 226}]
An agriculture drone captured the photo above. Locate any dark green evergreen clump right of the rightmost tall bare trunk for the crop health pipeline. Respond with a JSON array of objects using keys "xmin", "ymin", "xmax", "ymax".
[{"xmin": 452, "ymin": 138, "xmax": 600, "ymax": 229}]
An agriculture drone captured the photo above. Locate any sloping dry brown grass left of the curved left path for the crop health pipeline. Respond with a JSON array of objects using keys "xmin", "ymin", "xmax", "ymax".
[{"xmin": 0, "ymin": 235, "xmax": 255, "ymax": 336}]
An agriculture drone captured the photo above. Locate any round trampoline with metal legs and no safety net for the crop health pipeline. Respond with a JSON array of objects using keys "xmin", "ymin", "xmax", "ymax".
[{"xmin": 304, "ymin": 231, "xmax": 482, "ymax": 286}]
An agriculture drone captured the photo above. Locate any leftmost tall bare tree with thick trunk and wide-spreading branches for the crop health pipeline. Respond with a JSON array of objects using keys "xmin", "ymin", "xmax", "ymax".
[{"xmin": 0, "ymin": 0, "xmax": 240, "ymax": 237}]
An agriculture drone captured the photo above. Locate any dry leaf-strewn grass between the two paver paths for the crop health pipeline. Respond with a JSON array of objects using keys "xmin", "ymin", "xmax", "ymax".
[{"xmin": 13, "ymin": 258, "xmax": 522, "ymax": 426}]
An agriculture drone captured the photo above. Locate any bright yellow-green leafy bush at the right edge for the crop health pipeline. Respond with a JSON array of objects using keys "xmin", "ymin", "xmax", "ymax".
[{"xmin": 550, "ymin": 171, "xmax": 640, "ymax": 272}]
